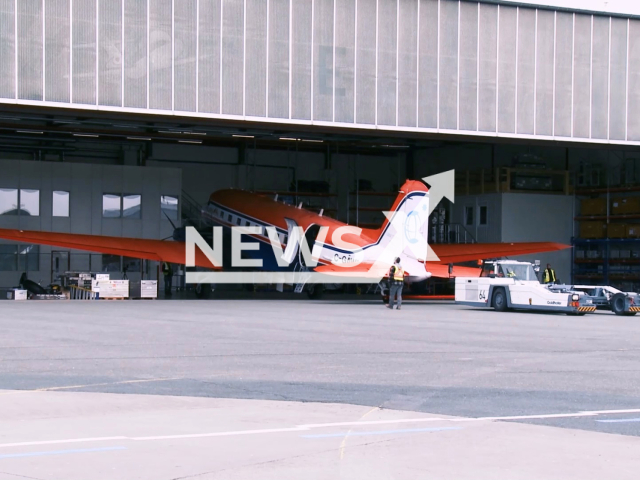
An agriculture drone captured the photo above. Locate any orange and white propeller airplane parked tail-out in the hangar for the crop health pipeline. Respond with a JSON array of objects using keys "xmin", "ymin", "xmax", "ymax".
[{"xmin": 0, "ymin": 180, "xmax": 569, "ymax": 296}]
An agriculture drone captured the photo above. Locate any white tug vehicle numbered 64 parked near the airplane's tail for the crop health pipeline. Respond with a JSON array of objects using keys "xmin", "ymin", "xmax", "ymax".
[{"xmin": 455, "ymin": 260, "xmax": 596, "ymax": 315}]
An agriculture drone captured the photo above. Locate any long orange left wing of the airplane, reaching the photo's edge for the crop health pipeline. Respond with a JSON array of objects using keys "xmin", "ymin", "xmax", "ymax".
[{"xmin": 0, "ymin": 228, "xmax": 220, "ymax": 269}]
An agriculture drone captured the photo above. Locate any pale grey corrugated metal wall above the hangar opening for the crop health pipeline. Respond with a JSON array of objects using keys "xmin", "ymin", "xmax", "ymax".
[{"xmin": 0, "ymin": 0, "xmax": 640, "ymax": 142}]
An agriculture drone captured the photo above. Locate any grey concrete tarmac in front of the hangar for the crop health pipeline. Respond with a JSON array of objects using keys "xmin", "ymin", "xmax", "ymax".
[{"xmin": 0, "ymin": 297, "xmax": 640, "ymax": 480}]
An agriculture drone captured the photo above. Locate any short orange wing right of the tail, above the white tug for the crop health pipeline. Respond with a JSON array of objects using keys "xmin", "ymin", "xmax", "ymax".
[{"xmin": 429, "ymin": 242, "xmax": 571, "ymax": 268}]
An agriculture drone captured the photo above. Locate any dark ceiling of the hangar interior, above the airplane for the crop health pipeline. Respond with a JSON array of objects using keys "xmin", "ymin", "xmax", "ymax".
[{"xmin": 0, "ymin": 107, "xmax": 640, "ymax": 214}]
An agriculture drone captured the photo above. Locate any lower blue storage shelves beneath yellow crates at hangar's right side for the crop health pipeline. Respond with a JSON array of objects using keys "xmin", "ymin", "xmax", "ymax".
[{"xmin": 571, "ymin": 238, "xmax": 640, "ymax": 292}]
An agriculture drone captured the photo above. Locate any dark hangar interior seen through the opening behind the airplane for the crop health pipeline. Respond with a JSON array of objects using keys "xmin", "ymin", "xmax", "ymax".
[{"xmin": 0, "ymin": 109, "xmax": 640, "ymax": 298}]
